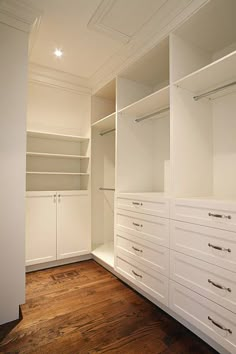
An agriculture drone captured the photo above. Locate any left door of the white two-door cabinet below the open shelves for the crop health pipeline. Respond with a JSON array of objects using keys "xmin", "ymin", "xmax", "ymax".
[{"xmin": 26, "ymin": 192, "xmax": 56, "ymax": 265}]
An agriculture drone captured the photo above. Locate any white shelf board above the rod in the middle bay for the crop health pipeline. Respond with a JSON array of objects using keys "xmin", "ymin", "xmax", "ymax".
[{"xmin": 119, "ymin": 85, "xmax": 170, "ymax": 118}]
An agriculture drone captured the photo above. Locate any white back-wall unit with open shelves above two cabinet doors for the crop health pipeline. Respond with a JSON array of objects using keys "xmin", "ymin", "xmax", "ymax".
[{"xmin": 26, "ymin": 131, "xmax": 91, "ymax": 266}]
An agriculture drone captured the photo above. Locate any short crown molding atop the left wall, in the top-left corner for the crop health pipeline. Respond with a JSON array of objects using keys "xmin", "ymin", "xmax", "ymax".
[{"xmin": 0, "ymin": 0, "xmax": 41, "ymax": 33}]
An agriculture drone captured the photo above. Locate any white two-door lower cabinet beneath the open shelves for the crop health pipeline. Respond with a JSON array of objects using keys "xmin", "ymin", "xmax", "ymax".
[{"xmin": 26, "ymin": 191, "xmax": 91, "ymax": 265}]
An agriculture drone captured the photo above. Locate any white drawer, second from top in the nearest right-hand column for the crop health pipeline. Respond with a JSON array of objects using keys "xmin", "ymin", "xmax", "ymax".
[{"xmin": 170, "ymin": 220, "xmax": 236, "ymax": 272}]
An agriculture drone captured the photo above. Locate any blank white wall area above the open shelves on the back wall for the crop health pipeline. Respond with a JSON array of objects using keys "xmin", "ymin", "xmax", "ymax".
[{"xmin": 27, "ymin": 82, "xmax": 91, "ymax": 136}]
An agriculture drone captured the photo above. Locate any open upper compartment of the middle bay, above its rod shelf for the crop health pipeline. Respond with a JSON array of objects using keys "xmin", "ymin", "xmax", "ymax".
[{"xmin": 117, "ymin": 38, "xmax": 169, "ymax": 110}]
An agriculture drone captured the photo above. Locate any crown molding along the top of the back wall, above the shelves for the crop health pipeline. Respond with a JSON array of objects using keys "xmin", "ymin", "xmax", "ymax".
[{"xmin": 29, "ymin": 63, "xmax": 91, "ymax": 95}]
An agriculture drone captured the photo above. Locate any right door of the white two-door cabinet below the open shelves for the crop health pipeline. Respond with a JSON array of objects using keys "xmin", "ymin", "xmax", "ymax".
[{"xmin": 57, "ymin": 191, "xmax": 91, "ymax": 259}]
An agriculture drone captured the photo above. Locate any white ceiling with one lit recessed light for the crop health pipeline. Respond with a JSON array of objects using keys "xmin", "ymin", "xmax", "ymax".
[{"xmin": 29, "ymin": 0, "xmax": 206, "ymax": 88}]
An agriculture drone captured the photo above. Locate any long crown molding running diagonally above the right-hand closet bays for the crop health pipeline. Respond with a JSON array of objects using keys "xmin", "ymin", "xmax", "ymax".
[{"xmin": 89, "ymin": 0, "xmax": 209, "ymax": 91}]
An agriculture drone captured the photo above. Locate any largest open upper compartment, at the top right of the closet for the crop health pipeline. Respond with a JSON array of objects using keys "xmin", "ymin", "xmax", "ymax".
[{"xmin": 170, "ymin": 0, "xmax": 236, "ymax": 82}]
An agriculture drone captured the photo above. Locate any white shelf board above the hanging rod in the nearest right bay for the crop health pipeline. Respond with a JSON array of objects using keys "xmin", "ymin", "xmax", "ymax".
[{"xmin": 174, "ymin": 51, "xmax": 236, "ymax": 94}]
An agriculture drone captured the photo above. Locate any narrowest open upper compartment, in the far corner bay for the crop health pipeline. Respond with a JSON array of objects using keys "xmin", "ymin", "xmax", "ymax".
[{"xmin": 91, "ymin": 79, "xmax": 116, "ymax": 128}]
